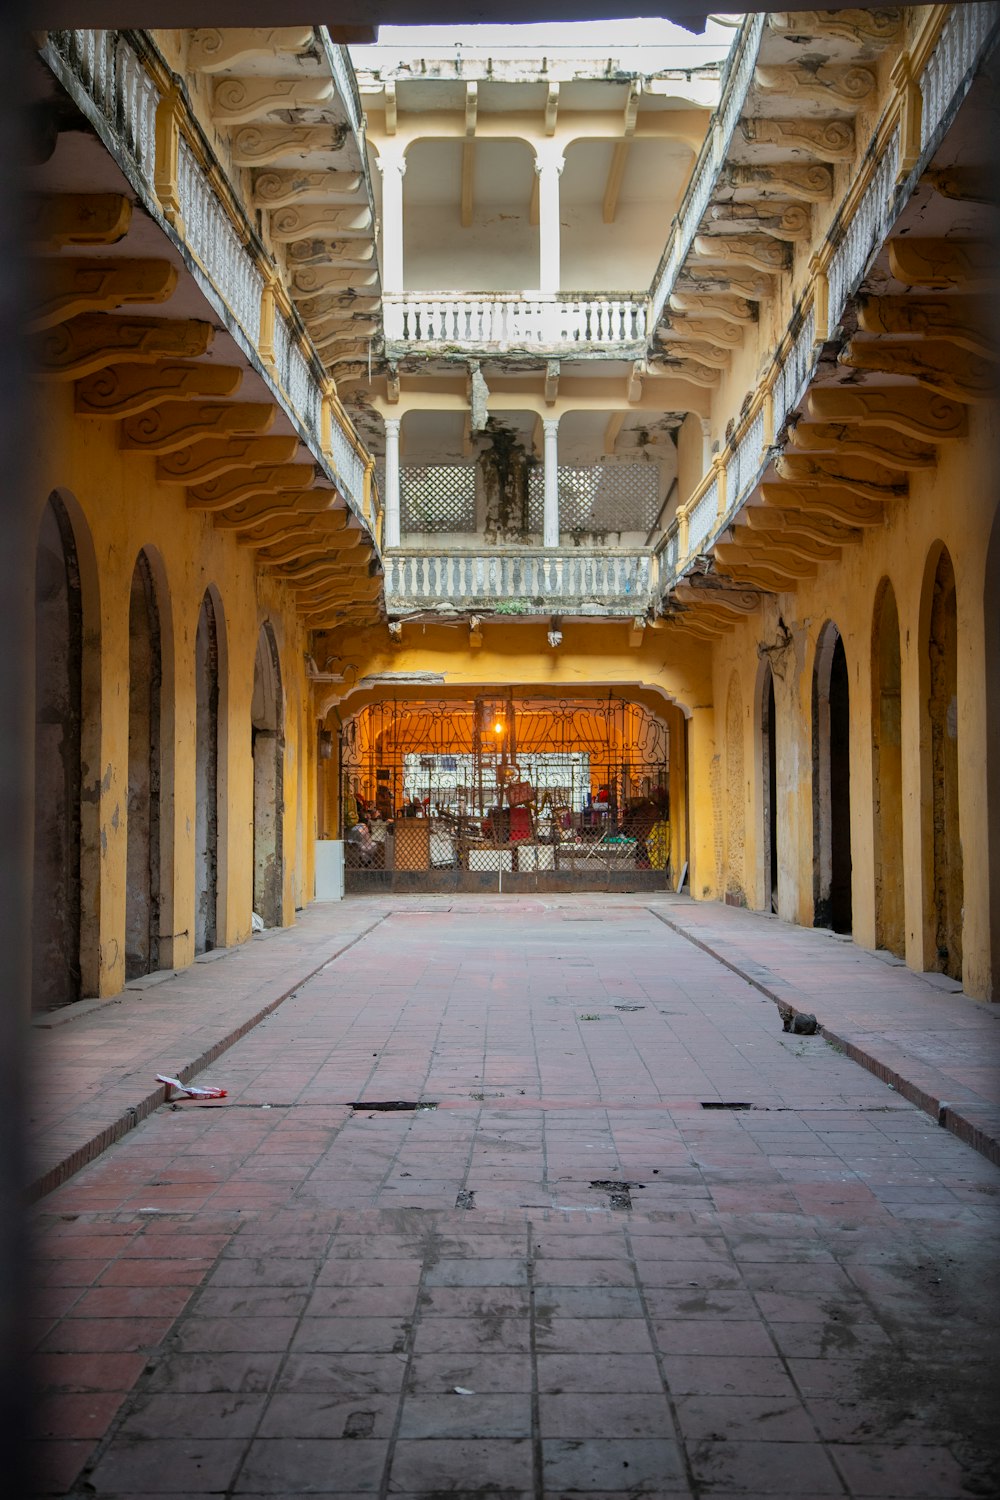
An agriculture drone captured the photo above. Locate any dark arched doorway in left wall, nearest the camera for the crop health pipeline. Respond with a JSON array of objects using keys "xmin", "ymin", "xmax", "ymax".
[{"xmin": 31, "ymin": 494, "xmax": 84, "ymax": 1011}]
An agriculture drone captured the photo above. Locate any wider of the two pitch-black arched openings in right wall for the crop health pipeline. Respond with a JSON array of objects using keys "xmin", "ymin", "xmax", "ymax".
[{"xmin": 813, "ymin": 621, "xmax": 852, "ymax": 933}]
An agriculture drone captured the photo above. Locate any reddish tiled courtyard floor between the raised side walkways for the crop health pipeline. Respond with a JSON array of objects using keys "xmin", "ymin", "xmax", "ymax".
[{"xmin": 27, "ymin": 897, "xmax": 1000, "ymax": 1500}]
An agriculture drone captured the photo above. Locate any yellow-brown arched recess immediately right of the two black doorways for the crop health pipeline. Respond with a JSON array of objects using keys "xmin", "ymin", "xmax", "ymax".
[{"xmin": 871, "ymin": 578, "xmax": 906, "ymax": 957}]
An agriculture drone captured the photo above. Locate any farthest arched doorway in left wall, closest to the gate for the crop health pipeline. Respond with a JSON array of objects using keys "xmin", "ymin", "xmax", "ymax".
[{"xmin": 250, "ymin": 624, "xmax": 285, "ymax": 927}]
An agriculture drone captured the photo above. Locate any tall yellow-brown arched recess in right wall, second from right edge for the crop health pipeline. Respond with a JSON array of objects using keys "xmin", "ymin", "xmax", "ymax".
[{"xmin": 921, "ymin": 548, "xmax": 964, "ymax": 980}]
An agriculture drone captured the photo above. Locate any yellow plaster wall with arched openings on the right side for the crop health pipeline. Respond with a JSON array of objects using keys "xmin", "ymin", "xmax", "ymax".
[{"xmin": 712, "ymin": 404, "xmax": 1000, "ymax": 998}]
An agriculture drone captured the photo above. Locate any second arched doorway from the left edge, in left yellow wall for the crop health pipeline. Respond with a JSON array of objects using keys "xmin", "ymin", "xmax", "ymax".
[{"xmin": 124, "ymin": 552, "xmax": 163, "ymax": 980}]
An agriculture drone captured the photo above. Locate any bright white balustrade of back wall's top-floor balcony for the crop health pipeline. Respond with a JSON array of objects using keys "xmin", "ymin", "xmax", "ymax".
[{"xmin": 382, "ymin": 293, "xmax": 646, "ymax": 357}]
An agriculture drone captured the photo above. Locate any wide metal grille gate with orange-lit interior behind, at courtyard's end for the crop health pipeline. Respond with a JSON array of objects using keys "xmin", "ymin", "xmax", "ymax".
[{"xmin": 340, "ymin": 692, "xmax": 670, "ymax": 894}]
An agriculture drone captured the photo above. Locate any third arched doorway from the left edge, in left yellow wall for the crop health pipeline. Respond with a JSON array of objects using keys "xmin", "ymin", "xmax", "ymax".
[{"xmin": 195, "ymin": 593, "xmax": 220, "ymax": 953}]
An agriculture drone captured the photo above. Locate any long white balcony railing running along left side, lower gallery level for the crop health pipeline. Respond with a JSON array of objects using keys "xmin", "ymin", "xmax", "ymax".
[{"xmin": 42, "ymin": 30, "xmax": 379, "ymax": 537}]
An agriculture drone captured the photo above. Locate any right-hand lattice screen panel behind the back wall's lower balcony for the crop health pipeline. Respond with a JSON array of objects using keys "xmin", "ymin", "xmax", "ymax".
[{"xmin": 528, "ymin": 462, "xmax": 660, "ymax": 531}]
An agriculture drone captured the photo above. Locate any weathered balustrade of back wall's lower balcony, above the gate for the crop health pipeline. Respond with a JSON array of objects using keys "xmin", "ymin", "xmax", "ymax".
[{"xmin": 385, "ymin": 548, "xmax": 655, "ymax": 615}]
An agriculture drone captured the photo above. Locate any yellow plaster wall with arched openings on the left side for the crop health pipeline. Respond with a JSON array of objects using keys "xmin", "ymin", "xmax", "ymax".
[{"xmin": 31, "ymin": 384, "xmax": 315, "ymax": 995}]
